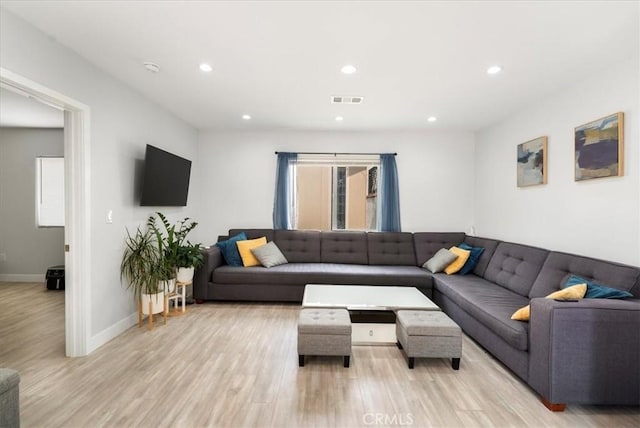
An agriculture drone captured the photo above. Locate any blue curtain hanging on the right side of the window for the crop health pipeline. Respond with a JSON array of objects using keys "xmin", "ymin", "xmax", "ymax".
[{"xmin": 378, "ymin": 154, "xmax": 400, "ymax": 232}]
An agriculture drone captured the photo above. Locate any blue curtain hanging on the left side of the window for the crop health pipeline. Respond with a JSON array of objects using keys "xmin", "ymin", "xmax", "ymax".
[{"xmin": 273, "ymin": 152, "xmax": 298, "ymax": 229}]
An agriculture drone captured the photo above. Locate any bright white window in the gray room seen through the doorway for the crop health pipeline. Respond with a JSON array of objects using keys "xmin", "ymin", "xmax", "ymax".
[{"xmin": 36, "ymin": 157, "xmax": 64, "ymax": 227}]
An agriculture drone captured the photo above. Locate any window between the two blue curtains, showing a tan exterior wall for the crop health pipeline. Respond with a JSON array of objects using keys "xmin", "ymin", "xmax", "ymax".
[{"xmin": 295, "ymin": 155, "xmax": 379, "ymax": 230}]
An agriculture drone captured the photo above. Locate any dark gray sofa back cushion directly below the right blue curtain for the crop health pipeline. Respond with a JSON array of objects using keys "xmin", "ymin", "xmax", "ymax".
[{"xmin": 367, "ymin": 232, "xmax": 417, "ymax": 266}]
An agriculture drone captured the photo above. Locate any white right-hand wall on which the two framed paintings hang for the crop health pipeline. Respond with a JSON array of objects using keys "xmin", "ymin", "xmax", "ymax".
[{"xmin": 474, "ymin": 53, "xmax": 640, "ymax": 265}]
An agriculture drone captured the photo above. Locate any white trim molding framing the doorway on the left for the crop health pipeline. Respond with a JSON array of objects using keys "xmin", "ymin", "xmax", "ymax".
[{"xmin": 0, "ymin": 68, "xmax": 93, "ymax": 357}]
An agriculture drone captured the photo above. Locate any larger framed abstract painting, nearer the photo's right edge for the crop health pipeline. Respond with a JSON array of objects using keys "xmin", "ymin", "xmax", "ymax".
[{"xmin": 574, "ymin": 113, "xmax": 624, "ymax": 181}]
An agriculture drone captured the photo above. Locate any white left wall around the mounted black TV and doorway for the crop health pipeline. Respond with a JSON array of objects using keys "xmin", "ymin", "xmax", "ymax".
[{"xmin": 0, "ymin": 9, "xmax": 199, "ymax": 348}]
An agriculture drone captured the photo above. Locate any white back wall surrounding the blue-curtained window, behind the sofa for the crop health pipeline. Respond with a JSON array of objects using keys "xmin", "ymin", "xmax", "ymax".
[{"xmin": 199, "ymin": 131, "xmax": 474, "ymax": 241}]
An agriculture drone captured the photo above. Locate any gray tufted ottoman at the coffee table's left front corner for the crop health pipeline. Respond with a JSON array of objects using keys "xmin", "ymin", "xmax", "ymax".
[{"xmin": 298, "ymin": 308, "xmax": 351, "ymax": 367}]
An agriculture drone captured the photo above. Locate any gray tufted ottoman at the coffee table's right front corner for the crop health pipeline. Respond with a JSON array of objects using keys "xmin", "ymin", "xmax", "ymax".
[{"xmin": 396, "ymin": 310, "xmax": 462, "ymax": 370}]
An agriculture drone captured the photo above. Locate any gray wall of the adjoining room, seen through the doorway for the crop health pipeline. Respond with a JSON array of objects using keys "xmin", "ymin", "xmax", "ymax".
[{"xmin": 0, "ymin": 128, "xmax": 64, "ymax": 280}]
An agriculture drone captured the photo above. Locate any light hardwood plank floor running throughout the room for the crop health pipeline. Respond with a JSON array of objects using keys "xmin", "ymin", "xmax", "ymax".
[{"xmin": 0, "ymin": 283, "xmax": 640, "ymax": 428}]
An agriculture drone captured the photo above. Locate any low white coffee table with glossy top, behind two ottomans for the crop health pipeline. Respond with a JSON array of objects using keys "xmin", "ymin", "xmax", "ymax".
[{"xmin": 302, "ymin": 284, "xmax": 440, "ymax": 345}]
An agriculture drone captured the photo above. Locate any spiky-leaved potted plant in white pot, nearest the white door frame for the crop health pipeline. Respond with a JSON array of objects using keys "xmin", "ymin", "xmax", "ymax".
[{"xmin": 120, "ymin": 228, "xmax": 164, "ymax": 315}]
